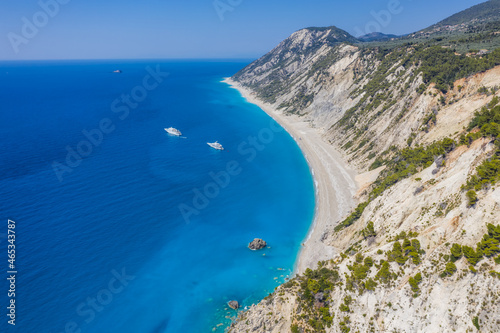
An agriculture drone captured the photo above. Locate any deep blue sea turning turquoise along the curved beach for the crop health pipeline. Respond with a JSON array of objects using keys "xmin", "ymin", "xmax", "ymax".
[{"xmin": 0, "ymin": 60, "xmax": 314, "ymax": 333}]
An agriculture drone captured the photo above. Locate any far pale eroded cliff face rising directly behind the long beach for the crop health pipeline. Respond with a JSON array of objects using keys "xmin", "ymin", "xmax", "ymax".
[{"xmin": 234, "ymin": 29, "xmax": 500, "ymax": 171}]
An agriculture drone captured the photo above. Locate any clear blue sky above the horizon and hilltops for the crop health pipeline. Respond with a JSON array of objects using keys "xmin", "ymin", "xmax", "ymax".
[{"xmin": 0, "ymin": 0, "xmax": 483, "ymax": 60}]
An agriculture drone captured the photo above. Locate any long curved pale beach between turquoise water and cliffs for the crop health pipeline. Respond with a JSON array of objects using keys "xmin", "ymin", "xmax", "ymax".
[{"xmin": 222, "ymin": 78, "xmax": 359, "ymax": 274}]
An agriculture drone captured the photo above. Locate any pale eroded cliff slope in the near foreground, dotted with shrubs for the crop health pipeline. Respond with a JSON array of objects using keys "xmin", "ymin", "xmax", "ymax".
[{"xmin": 230, "ymin": 139, "xmax": 500, "ymax": 333}]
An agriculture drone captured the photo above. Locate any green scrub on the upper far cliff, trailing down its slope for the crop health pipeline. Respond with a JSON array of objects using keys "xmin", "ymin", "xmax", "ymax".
[{"xmin": 337, "ymin": 44, "xmax": 500, "ymax": 129}]
